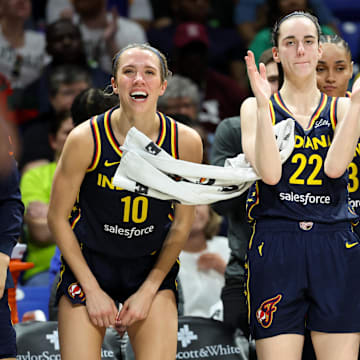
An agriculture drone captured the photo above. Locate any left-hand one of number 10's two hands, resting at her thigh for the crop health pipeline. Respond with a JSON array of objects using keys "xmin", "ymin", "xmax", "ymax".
[{"xmin": 86, "ymin": 287, "xmax": 118, "ymax": 327}]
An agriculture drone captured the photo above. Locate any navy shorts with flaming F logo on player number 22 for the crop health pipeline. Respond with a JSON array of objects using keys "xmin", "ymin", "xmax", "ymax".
[{"xmin": 247, "ymin": 220, "xmax": 360, "ymax": 339}]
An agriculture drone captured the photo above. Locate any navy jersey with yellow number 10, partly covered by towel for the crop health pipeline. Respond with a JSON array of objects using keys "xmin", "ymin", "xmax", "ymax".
[{"xmin": 70, "ymin": 108, "xmax": 178, "ymax": 257}]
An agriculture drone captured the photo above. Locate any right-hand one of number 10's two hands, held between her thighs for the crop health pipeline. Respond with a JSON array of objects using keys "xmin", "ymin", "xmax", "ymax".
[{"xmin": 115, "ymin": 288, "xmax": 153, "ymax": 327}]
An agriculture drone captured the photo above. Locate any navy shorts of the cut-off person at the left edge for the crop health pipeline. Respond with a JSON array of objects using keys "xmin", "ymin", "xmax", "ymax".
[{"xmin": 0, "ymin": 290, "xmax": 17, "ymax": 359}]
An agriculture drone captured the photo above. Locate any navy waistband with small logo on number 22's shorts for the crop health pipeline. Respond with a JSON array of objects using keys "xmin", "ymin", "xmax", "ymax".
[{"xmin": 255, "ymin": 218, "xmax": 352, "ymax": 232}]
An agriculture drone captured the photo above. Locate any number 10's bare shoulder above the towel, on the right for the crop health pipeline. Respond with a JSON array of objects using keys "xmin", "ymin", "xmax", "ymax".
[{"xmin": 178, "ymin": 123, "xmax": 203, "ymax": 163}]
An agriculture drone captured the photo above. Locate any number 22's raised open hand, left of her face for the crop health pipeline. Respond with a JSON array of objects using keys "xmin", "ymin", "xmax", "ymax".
[{"xmin": 245, "ymin": 50, "xmax": 271, "ymax": 105}]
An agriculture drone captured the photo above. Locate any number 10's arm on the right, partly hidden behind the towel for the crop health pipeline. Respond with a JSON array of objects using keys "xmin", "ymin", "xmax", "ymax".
[{"xmin": 119, "ymin": 124, "xmax": 203, "ymax": 326}]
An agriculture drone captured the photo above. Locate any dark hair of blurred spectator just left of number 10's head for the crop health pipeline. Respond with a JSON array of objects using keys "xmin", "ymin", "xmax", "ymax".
[{"xmin": 48, "ymin": 64, "xmax": 91, "ymax": 97}]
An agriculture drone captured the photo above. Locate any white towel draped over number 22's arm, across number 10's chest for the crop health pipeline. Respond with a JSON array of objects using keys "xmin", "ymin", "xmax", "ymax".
[{"xmin": 113, "ymin": 119, "xmax": 294, "ymax": 205}]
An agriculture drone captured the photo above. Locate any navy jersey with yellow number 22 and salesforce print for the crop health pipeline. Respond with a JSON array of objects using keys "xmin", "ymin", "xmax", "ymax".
[{"xmin": 247, "ymin": 92, "xmax": 357, "ymax": 223}]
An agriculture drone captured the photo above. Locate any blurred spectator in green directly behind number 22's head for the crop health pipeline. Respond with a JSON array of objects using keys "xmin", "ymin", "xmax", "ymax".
[{"xmin": 249, "ymin": 0, "xmax": 334, "ymax": 64}]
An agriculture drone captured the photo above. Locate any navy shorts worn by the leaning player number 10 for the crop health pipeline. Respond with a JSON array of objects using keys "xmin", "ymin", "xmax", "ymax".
[{"xmin": 56, "ymin": 243, "xmax": 179, "ymax": 304}]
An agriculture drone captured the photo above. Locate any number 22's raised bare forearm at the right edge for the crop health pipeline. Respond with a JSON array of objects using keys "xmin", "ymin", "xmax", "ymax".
[{"xmin": 324, "ymin": 92, "xmax": 360, "ymax": 178}]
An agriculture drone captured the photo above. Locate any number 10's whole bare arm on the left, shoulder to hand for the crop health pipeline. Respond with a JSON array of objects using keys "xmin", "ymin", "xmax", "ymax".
[{"xmin": 48, "ymin": 122, "xmax": 117, "ymax": 327}]
